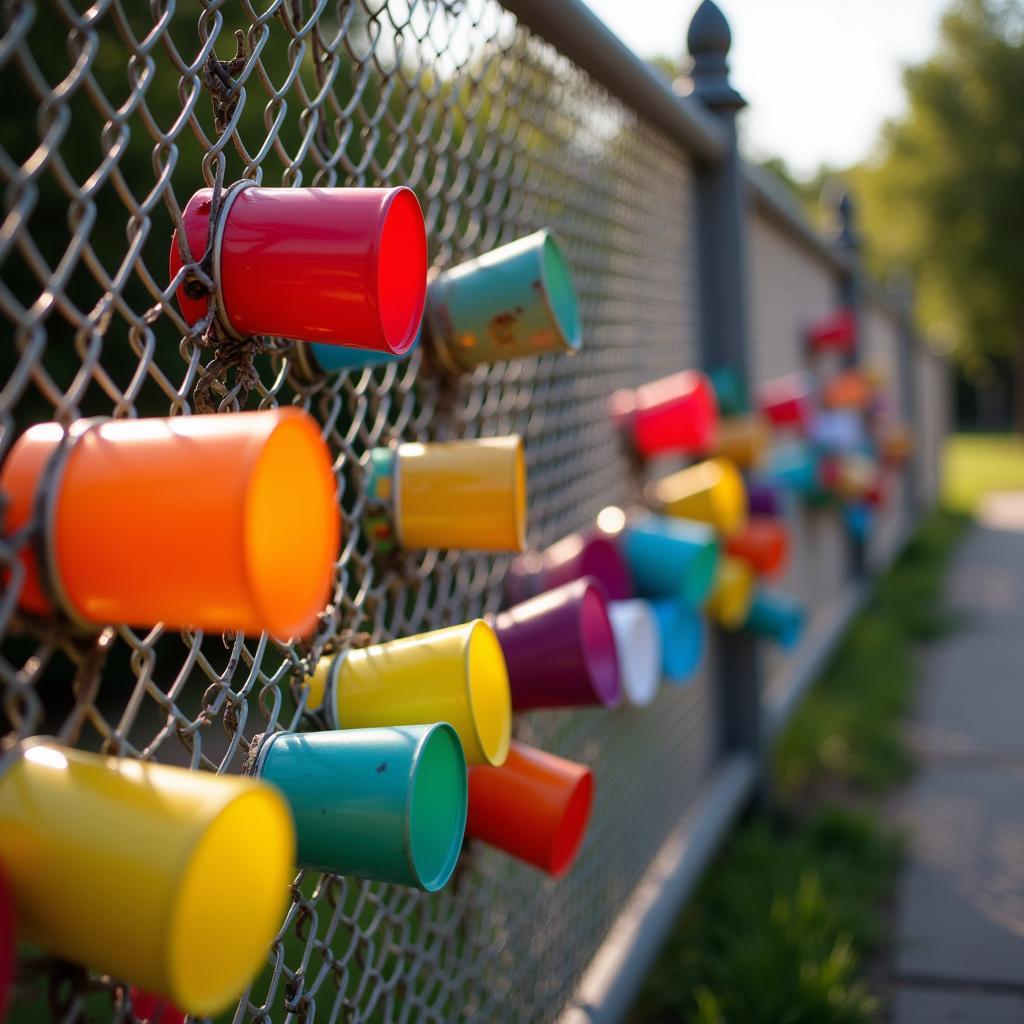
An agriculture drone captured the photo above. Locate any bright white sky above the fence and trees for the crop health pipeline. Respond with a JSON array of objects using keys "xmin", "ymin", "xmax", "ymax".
[{"xmin": 585, "ymin": 0, "xmax": 949, "ymax": 176}]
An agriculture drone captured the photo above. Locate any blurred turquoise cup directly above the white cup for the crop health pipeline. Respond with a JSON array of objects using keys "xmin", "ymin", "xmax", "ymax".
[{"xmin": 622, "ymin": 515, "xmax": 719, "ymax": 607}]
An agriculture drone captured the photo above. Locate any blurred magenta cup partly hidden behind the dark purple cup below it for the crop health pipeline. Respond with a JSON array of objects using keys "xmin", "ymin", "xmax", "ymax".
[{"xmin": 505, "ymin": 529, "xmax": 633, "ymax": 602}]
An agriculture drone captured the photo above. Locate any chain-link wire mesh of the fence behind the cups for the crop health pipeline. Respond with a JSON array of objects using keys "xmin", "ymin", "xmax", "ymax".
[{"xmin": 0, "ymin": 0, "xmax": 945, "ymax": 1022}]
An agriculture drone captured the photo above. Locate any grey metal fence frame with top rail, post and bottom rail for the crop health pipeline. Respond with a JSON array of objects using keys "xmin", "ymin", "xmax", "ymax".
[{"xmin": 0, "ymin": 0, "xmax": 944, "ymax": 1024}]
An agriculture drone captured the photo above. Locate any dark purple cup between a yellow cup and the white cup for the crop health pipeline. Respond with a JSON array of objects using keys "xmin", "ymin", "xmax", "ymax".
[{"xmin": 495, "ymin": 578, "xmax": 622, "ymax": 711}]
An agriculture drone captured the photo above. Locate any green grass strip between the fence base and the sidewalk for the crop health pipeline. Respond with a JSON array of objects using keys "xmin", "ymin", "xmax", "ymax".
[{"xmin": 631, "ymin": 513, "xmax": 967, "ymax": 1024}]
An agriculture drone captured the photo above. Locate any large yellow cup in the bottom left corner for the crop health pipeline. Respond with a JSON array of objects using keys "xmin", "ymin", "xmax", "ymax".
[{"xmin": 0, "ymin": 742, "xmax": 295, "ymax": 1016}]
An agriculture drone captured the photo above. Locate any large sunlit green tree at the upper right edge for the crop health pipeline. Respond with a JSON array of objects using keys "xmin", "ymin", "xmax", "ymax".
[{"xmin": 848, "ymin": 0, "xmax": 1024, "ymax": 428}]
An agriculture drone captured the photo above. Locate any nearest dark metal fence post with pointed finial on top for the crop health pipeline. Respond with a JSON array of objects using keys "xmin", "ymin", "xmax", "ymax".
[{"xmin": 686, "ymin": 0, "xmax": 762, "ymax": 753}]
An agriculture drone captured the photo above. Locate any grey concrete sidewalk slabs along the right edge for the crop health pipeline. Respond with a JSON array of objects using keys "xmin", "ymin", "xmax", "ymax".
[{"xmin": 891, "ymin": 503, "xmax": 1024, "ymax": 1024}]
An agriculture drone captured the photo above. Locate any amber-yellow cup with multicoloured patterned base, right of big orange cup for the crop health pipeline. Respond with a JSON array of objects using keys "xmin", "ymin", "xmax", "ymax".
[{"xmin": 367, "ymin": 435, "xmax": 526, "ymax": 551}]
